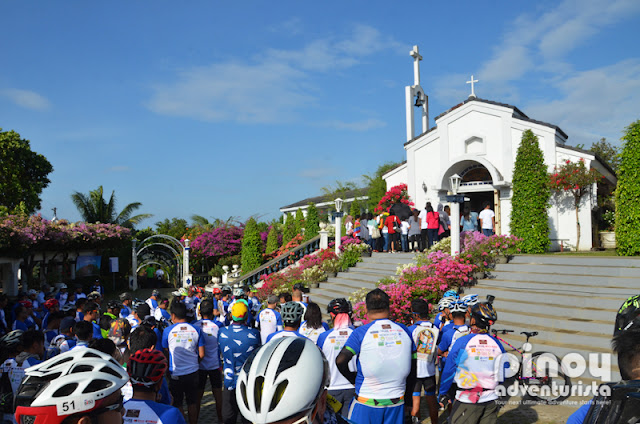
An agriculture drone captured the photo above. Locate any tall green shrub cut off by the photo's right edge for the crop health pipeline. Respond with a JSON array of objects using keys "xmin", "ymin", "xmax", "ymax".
[{"xmin": 615, "ymin": 120, "xmax": 640, "ymax": 256}]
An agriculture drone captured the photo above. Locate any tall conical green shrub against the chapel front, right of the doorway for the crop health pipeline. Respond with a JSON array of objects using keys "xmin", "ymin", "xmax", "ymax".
[{"xmin": 510, "ymin": 130, "xmax": 551, "ymax": 253}]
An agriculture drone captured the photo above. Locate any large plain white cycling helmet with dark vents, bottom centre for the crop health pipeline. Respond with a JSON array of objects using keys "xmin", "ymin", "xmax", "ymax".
[{"xmin": 236, "ymin": 337, "xmax": 330, "ymax": 424}]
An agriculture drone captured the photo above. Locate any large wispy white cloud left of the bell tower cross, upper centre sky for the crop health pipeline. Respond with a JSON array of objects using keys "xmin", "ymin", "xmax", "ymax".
[{"xmin": 146, "ymin": 25, "xmax": 398, "ymax": 125}]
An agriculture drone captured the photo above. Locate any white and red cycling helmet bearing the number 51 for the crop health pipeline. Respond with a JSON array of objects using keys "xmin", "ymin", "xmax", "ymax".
[{"xmin": 15, "ymin": 348, "xmax": 129, "ymax": 424}]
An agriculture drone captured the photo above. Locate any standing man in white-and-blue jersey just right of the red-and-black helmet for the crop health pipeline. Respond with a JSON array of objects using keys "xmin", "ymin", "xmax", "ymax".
[{"xmin": 162, "ymin": 302, "xmax": 205, "ymax": 424}]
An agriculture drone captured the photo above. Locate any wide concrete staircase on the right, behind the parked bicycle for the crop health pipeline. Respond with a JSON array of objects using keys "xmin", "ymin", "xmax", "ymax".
[{"xmin": 472, "ymin": 255, "xmax": 640, "ymax": 381}]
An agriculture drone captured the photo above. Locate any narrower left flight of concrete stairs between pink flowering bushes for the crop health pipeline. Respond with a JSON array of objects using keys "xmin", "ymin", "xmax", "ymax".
[{"xmin": 309, "ymin": 252, "xmax": 415, "ymax": 318}]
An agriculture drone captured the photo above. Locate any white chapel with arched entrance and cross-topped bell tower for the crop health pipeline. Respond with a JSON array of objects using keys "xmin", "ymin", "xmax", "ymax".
[{"xmin": 383, "ymin": 46, "xmax": 616, "ymax": 250}]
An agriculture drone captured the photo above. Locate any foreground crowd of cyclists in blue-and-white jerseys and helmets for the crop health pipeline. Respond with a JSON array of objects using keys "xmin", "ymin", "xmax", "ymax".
[{"xmin": 0, "ymin": 278, "xmax": 640, "ymax": 424}]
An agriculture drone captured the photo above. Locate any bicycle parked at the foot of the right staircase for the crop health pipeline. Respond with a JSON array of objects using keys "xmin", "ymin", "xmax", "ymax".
[{"xmin": 491, "ymin": 329, "xmax": 571, "ymax": 404}]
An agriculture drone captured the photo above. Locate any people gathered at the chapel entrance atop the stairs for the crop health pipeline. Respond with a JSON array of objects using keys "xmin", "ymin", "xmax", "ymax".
[{"xmin": 344, "ymin": 202, "xmax": 496, "ymax": 253}]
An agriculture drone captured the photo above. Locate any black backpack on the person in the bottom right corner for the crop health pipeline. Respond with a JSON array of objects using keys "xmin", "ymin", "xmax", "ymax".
[{"xmin": 583, "ymin": 380, "xmax": 640, "ymax": 424}]
